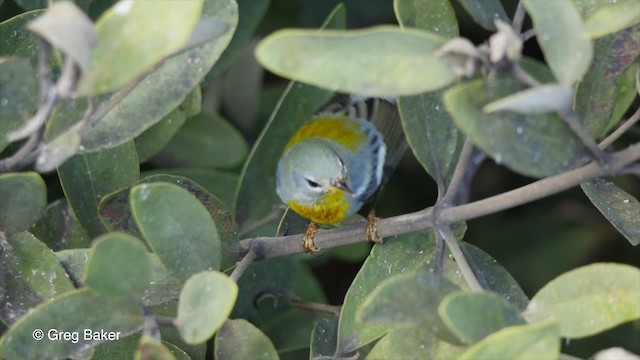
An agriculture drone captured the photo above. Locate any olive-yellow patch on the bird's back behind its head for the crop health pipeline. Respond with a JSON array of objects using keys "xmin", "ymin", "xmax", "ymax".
[{"xmin": 285, "ymin": 116, "xmax": 367, "ymax": 152}]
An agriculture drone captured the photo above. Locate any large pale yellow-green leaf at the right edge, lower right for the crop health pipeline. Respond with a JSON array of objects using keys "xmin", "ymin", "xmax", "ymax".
[{"xmin": 523, "ymin": 263, "xmax": 640, "ymax": 339}]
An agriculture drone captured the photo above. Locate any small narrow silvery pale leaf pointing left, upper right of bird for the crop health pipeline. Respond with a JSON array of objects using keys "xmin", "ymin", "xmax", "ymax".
[{"xmin": 483, "ymin": 84, "xmax": 573, "ymax": 115}]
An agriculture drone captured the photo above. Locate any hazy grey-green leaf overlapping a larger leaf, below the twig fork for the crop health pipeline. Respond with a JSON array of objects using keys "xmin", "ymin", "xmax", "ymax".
[{"xmin": 356, "ymin": 267, "xmax": 459, "ymax": 343}]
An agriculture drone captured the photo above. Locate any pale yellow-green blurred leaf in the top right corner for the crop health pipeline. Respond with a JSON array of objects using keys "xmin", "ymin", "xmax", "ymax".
[{"xmin": 584, "ymin": 0, "xmax": 640, "ymax": 39}]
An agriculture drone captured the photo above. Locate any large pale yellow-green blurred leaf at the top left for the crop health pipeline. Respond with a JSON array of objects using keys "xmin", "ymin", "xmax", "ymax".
[{"xmin": 79, "ymin": 0, "xmax": 204, "ymax": 95}]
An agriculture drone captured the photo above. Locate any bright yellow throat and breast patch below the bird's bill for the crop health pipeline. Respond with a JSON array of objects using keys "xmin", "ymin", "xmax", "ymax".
[{"xmin": 288, "ymin": 189, "xmax": 349, "ymax": 224}]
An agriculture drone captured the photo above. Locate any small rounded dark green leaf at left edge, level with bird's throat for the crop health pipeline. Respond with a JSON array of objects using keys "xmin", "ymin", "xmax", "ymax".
[{"xmin": 0, "ymin": 172, "xmax": 47, "ymax": 234}]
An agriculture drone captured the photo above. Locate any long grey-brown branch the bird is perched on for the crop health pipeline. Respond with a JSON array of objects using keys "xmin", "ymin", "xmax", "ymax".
[{"xmin": 240, "ymin": 143, "xmax": 640, "ymax": 259}]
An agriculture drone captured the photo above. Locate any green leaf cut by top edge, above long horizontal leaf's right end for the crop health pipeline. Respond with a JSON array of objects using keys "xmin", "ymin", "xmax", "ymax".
[{"xmin": 393, "ymin": 0, "xmax": 459, "ymax": 39}]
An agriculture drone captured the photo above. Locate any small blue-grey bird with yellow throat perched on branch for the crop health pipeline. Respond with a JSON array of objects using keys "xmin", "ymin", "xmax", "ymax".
[{"xmin": 276, "ymin": 95, "xmax": 407, "ymax": 255}]
